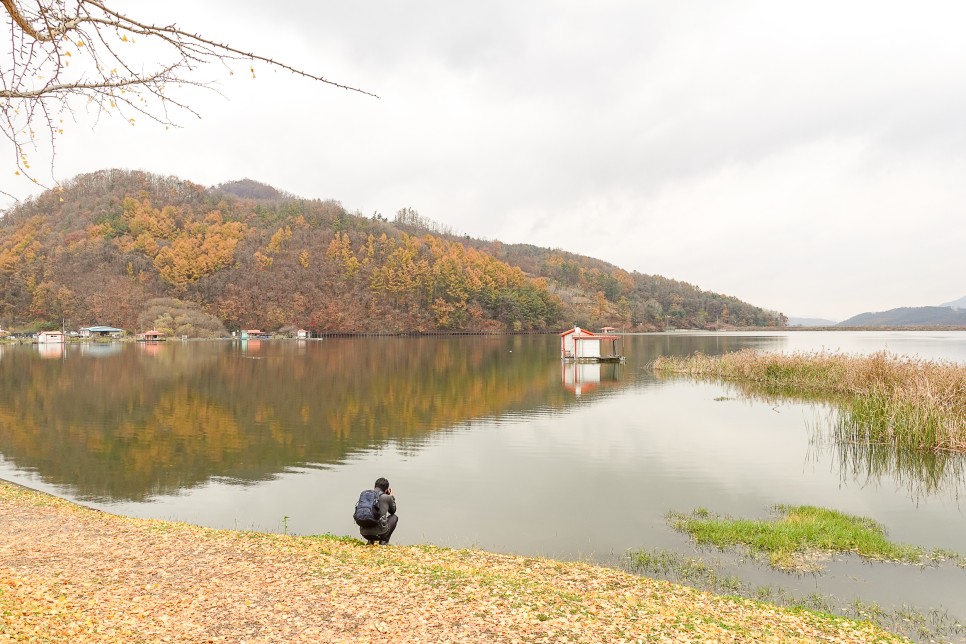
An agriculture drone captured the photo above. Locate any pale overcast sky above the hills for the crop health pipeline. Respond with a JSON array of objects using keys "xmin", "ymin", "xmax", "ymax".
[{"xmin": 0, "ymin": 0, "xmax": 966, "ymax": 320}]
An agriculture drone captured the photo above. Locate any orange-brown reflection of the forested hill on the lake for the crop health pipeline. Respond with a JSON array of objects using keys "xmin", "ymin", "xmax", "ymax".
[{"xmin": 0, "ymin": 338, "xmax": 566, "ymax": 500}]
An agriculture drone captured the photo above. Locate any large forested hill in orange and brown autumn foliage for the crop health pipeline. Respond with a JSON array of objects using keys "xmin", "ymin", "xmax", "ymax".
[{"xmin": 0, "ymin": 170, "xmax": 785, "ymax": 336}]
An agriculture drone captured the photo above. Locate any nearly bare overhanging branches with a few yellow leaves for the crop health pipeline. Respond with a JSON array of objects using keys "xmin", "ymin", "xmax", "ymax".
[{"xmin": 0, "ymin": 0, "xmax": 375, "ymax": 194}]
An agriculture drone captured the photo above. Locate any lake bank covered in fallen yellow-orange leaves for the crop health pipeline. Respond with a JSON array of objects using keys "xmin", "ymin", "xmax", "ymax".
[{"xmin": 0, "ymin": 481, "xmax": 906, "ymax": 642}]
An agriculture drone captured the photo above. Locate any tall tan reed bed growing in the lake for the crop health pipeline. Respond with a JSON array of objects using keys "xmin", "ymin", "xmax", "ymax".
[{"xmin": 653, "ymin": 350, "xmax": 966, "ymax": 452}]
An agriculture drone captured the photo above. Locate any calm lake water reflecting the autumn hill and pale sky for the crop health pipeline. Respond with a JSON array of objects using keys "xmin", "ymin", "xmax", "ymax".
[{"xmin": 0, "ymin": 331, "xmax": 966, "ymax": 618}]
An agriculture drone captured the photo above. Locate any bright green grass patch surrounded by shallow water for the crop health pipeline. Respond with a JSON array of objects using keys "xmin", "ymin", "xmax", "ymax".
[{"xmin": 668, "ymin": 505, "xmax": 941, "ymax": 570}]
